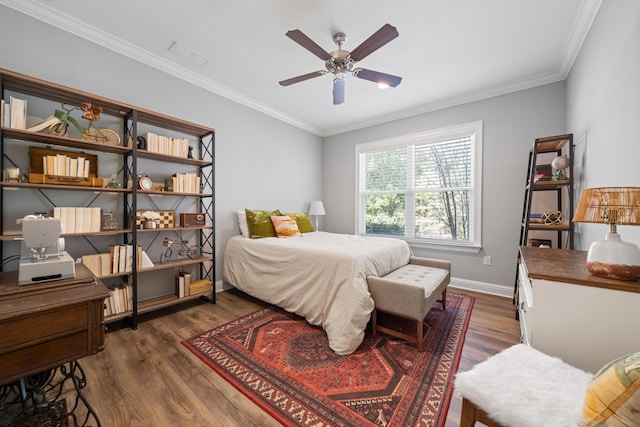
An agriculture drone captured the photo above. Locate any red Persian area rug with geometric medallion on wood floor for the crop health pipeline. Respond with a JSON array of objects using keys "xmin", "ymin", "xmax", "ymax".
[{"xmin": 182, "ymin": 293, "xmax": 474, "ymax": 427}]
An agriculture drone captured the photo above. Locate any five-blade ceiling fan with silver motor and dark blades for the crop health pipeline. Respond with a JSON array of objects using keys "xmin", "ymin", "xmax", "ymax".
[{"xmin": 280, "ymin": 24, "xmax": 402, "ymax": 105}]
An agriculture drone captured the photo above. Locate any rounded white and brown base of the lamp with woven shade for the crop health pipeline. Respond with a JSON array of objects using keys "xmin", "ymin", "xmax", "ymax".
[{"xmin": 587, "ymin": 233, "xmax": 640, "ymax": 280}]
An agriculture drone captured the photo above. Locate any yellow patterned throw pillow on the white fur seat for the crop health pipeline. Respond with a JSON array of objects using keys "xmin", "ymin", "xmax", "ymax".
[{"xmin": 582, "ymin": 353, "xmax": 640, "ymax": 427}]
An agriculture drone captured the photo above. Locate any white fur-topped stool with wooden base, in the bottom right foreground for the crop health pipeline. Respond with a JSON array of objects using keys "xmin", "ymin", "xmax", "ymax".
[{"xmin": 455, "ymin": 344, "xmax": 593, "ymax": 427}]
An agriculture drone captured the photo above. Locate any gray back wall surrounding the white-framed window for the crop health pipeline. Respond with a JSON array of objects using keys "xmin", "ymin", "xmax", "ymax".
[{"xmin": 324, "ymin": 82, "xmax": 565, "ymax": 295}]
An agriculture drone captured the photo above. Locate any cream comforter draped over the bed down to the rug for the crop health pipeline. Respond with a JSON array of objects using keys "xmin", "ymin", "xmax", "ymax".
[{"xmin": 223, "ymin": 232, "xmax": 411, "ymax": 354}]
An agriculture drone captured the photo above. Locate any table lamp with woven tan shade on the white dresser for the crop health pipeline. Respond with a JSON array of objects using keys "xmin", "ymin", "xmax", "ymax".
[{"xmin": 573, "ymin": 187, "xmax": 640, "ymax": 280}]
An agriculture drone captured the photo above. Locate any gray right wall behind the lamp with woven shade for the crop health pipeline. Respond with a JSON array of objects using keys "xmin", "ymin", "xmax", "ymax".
[{"xmin": 567, "ymin": 0, "xmax": 640, "ymax": 250}]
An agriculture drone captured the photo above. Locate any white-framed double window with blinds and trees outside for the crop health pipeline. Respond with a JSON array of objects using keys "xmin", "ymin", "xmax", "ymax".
[{"xmin": 356, "ymin": 121, "xmax": 482, "ymax": 248}]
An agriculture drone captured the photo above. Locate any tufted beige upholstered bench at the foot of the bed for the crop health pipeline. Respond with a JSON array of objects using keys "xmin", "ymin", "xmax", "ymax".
[{"xmin": 367, "ymin": 257, "xmax": 451, "ymax": 351}]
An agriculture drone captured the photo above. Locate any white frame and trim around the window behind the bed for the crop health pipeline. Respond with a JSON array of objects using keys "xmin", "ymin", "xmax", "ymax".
[{"xmin": 355, "ymin": 120, "xmax": 483, "ymax": 253}]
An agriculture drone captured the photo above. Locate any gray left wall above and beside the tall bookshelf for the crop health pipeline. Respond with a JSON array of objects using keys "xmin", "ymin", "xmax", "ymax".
[{"xmin": 0, "ymin": 6, "xmax": 322, "ymax": 290}]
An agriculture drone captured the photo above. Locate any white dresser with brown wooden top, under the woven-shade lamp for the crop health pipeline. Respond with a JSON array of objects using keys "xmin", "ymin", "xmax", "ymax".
[{"xmin": 518, "ymin": 246, "xmax": 640, "ymax": 373}]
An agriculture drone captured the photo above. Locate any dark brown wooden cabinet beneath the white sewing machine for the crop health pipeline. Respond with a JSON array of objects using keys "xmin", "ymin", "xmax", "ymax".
[{"xmin": 0, "ymin": 264, "xmax": 109, "ymax": 385}]
